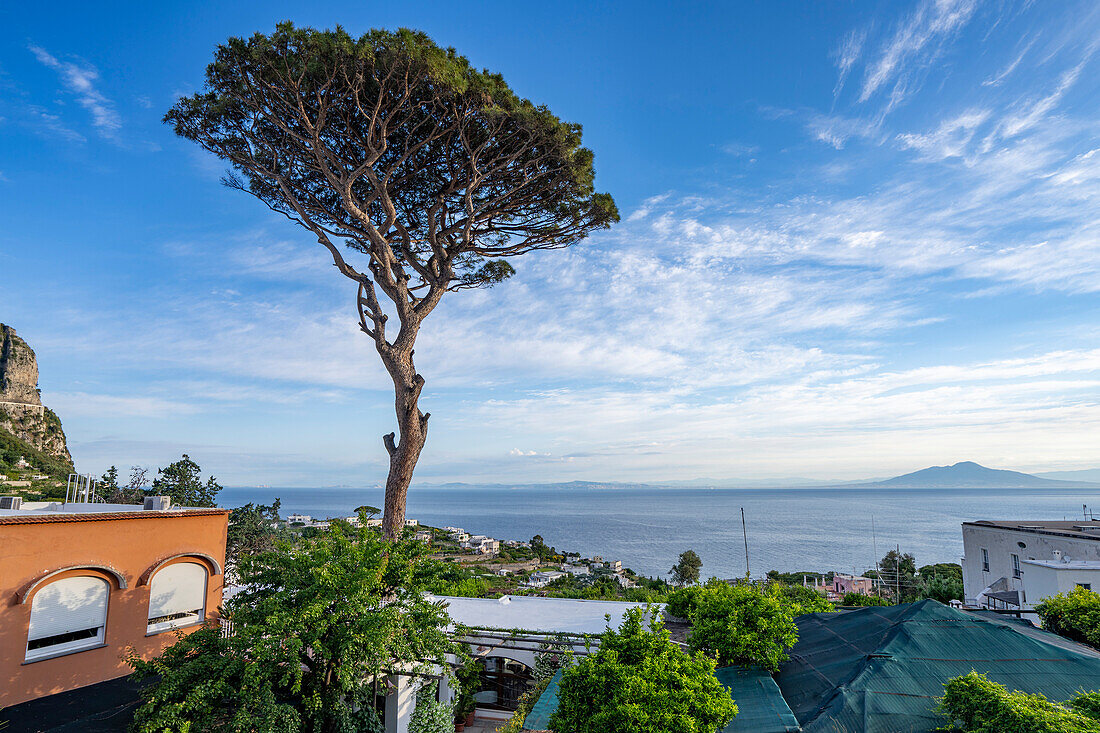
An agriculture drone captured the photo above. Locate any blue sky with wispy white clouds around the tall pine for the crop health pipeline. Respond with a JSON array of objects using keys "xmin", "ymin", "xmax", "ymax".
[{"xmin": 0, "ymin": 0, "xmax": 1100, "ymax": 485}]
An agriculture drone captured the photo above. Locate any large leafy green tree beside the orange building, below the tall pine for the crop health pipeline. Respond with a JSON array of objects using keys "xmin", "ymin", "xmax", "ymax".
[{"xmin": 129, "ymin": 522, "xmax": 452, "ymax": 733}]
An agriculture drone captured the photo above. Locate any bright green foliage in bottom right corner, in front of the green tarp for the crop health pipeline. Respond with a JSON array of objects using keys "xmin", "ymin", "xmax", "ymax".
[{"xmin": 941, "ymin": 671, "xmax": 1100, "ymax": 733}]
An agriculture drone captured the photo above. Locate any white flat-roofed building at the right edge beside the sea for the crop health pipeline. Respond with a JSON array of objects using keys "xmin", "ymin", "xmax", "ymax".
[{"xmin": 961, "ymin": 519, "xmax": 1100, "ymax": 611}]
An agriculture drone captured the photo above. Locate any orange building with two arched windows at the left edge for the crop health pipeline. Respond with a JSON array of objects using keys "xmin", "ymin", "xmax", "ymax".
[{"xmin": 0, "ymin": 493, "xmax": 229, "ymax": 708}]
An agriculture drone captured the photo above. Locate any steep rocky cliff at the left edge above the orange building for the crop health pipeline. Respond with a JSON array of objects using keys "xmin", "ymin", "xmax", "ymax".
[{"xmin": 0, "ymin": 324, "xmax": 73, "ymax": 470}]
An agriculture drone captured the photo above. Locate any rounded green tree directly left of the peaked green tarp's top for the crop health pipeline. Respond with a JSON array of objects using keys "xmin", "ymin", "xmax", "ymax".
[{"xmin": 688, "ymin": 581, "xmax": 799, "ymax": 671}]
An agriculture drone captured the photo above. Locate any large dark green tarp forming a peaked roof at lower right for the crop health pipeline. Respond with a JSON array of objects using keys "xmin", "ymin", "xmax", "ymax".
[{"xmin": 777, "ymin": 600, "xmax": 1100, "ymax": 733}]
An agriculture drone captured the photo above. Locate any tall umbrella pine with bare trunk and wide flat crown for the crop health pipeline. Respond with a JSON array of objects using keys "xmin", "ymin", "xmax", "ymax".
[{"xmin": 165, "ymin": 22, "xmax": 618, "ymax": 537}]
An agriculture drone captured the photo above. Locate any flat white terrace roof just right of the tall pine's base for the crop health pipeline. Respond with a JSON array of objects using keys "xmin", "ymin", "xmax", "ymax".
[{"xmin": 430, "ymin": 595, "xmax": 646, "ymax": 634}]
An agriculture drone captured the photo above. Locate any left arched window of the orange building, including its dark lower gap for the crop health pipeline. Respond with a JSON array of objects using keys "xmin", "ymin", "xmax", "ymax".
[{"xmin": 25, "ymin": 576, "xmax": 111, "ymax": 661}]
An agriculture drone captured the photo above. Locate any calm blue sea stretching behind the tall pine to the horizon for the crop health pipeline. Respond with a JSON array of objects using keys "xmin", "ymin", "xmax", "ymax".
[{"xmin": 219, "ymin": 485, "xmax": 1100, "ymax": 578}]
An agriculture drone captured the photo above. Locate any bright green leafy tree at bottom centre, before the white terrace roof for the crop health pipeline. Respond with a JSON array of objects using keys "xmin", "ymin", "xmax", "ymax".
[{"xmin": 550, "ymin": 609, "xmax": 737, "ymax": 733}]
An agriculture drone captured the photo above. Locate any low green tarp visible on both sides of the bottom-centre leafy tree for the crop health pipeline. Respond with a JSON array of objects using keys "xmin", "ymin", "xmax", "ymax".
[{"xmin": 524, "ymin": 667, "xmax": 801, "ymax": 733}]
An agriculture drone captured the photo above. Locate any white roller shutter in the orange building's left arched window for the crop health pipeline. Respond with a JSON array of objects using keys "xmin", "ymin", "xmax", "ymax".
[{"xmin": 26, "ymin": 576, "xmax": 111, "ymax": 655}]
